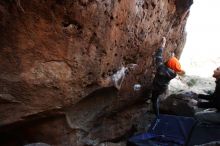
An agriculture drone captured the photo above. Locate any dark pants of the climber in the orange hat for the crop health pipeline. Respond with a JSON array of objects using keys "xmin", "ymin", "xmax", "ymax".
[{"xmin": 151, "ymin": 89, "xmax": 166, "ymax": 116}]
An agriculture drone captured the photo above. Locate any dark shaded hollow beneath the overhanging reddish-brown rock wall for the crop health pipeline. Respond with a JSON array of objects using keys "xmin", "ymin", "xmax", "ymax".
[{"xmin": 0, "ymin": 87, "xmax": 150, "ymax": 146}]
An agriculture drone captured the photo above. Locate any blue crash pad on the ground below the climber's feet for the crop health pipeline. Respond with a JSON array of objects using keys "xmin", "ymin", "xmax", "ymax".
[{"xmin": 128, "ymin": 115, "xmax": 196, "ymax": 146}]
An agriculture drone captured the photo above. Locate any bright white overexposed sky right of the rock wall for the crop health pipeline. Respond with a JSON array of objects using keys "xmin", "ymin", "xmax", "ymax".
[{"xmin": 180, "ymin": 0, "xmax": 220, "ymax": 77}]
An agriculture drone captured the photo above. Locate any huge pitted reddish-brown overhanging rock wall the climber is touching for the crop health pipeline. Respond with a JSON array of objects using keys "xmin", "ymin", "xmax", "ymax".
[{"xmin": 0, "ymin": 0, "xmax": 191, "ymax": 145}]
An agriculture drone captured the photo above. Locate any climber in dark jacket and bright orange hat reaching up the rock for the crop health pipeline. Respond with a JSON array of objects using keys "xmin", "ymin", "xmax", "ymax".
[{"xmin": 151, "ymin": 37, "xmax": 185, "ymax": 116}]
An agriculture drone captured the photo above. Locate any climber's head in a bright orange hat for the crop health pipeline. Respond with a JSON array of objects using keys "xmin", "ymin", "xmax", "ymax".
[{"xmin": 166, "ymin": 55, "xmax": 185, "ymax": 75}]
